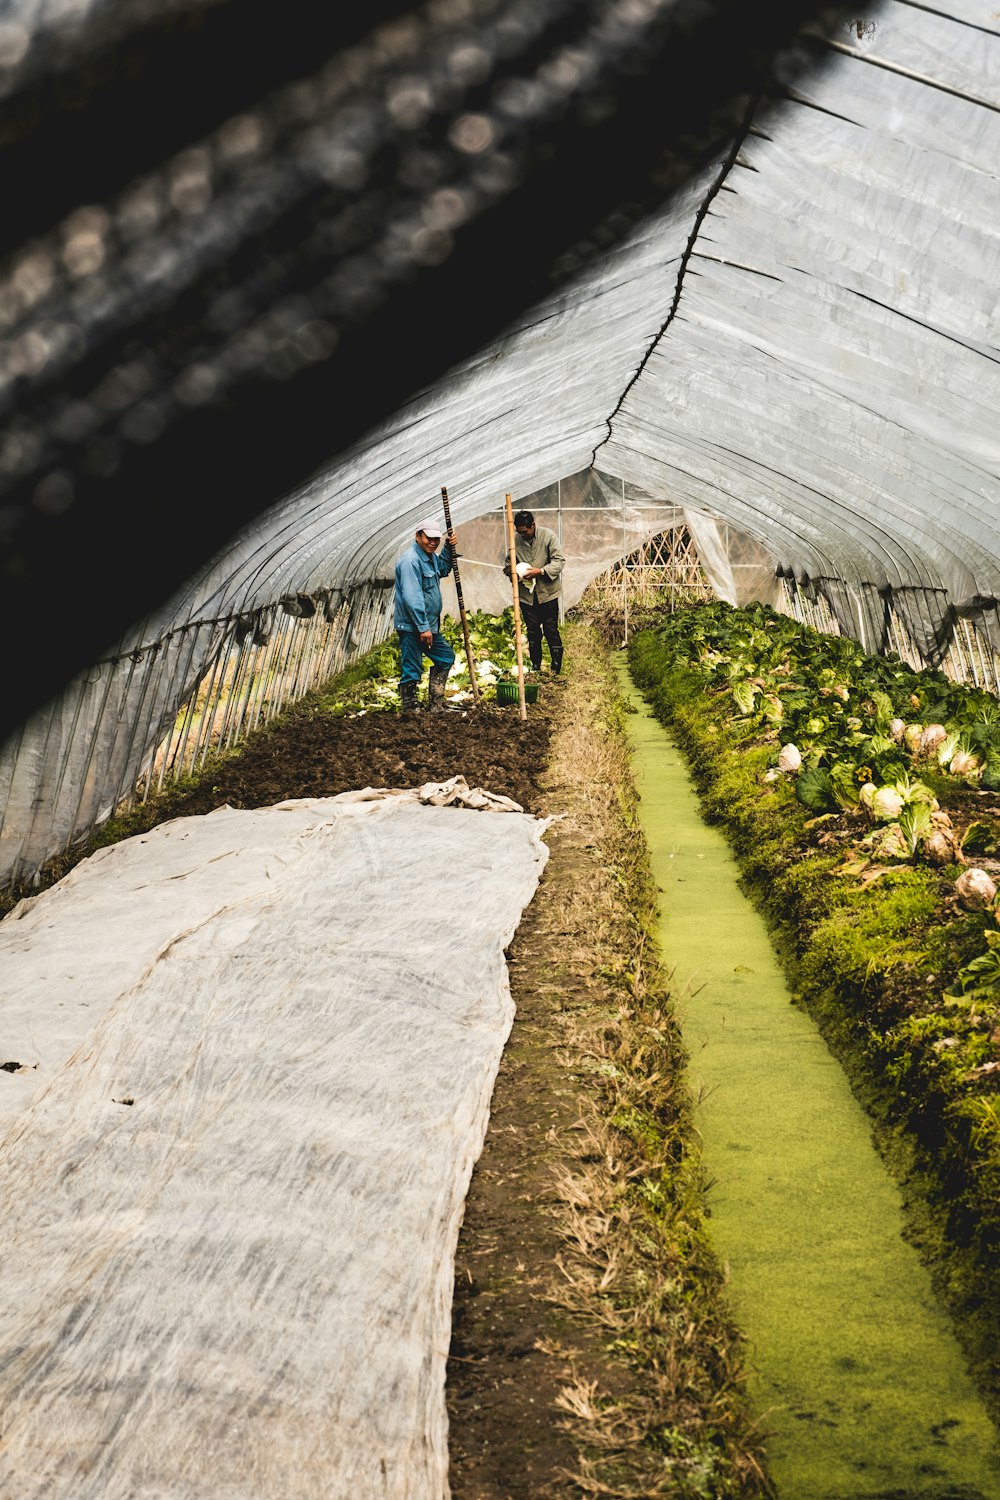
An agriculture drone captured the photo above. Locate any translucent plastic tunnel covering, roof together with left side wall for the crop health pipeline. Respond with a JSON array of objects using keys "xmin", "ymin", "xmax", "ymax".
[{"xmin": 0, "ymin": 0, "xmax": 1000, "ymax": 878}]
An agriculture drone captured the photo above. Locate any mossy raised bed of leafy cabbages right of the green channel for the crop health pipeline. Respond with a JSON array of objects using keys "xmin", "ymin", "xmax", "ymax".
[{"xmin": 630, "ymin": 605, "xmax": 1000, "ymax": 1418}]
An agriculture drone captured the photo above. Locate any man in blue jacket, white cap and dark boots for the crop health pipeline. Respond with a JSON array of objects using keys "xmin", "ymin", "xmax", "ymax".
[{"xmin": 393, "ymin": 521, "xmax": 457, "ymax": 714}]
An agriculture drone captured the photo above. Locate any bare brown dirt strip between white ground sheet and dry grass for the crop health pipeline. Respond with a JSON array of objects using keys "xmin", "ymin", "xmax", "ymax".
[{"xmin": 447, "ymin": 834, "xmax": 631, "ymax": 1500}]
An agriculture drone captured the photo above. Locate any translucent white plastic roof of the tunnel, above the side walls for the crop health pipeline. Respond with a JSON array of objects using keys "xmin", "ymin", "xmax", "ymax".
[{"xmin": 170, "ymin": 3, "xmax": 1000, "ymax": 642}]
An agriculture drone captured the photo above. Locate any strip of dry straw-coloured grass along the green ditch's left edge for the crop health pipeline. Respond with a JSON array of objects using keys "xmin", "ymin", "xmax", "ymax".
[{"xmin": 546, "ymin": 626, "xmax": 772, "ymax": 1500}]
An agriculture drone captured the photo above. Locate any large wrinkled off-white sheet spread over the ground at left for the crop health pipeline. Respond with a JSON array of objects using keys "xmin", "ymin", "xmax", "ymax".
[{"xmin": 0, "ymin": 779, "xmax": 546, "ymax": 1500}]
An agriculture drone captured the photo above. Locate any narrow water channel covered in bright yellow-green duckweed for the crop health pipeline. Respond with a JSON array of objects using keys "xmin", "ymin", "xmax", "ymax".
[{"xmin": 622, "ymin": 672, "xmax": 1000, "ymax": 1500}]
